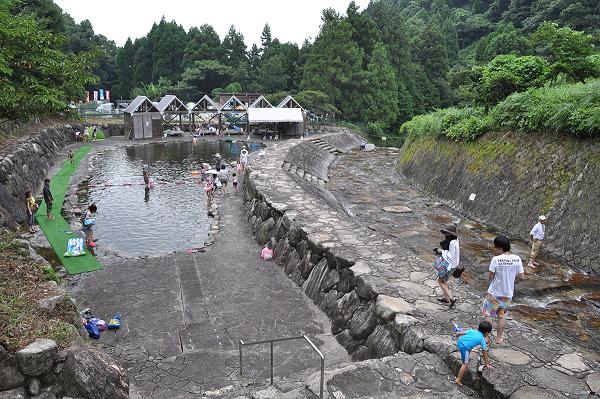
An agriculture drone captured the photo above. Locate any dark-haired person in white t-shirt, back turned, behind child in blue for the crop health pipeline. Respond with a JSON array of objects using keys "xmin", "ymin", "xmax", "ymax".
[{"xmin": 481, "ymin": 236, "xmax": 525, "ymax": 344}]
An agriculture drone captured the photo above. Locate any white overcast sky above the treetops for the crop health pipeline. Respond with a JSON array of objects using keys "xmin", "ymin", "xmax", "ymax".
[{"xmin": 54, "ymin": 0, "xmax": 369, "ymax": 47}]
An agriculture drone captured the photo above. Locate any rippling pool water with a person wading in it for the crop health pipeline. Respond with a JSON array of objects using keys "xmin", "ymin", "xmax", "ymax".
[{"xmin": 80, "ymin": 141, "xmax": 260, "ymax": 257}]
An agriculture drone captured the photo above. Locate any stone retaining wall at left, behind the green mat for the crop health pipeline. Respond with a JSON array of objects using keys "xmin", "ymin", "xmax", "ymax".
[{"xmin": 0, "ymin": 123, "xmax": 83, "ymax": 229}]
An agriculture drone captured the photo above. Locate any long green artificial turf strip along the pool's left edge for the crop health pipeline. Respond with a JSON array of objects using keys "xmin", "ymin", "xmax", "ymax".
[{"xmin": 36, "ymin": 145, "xmax": 102, "ymax": 274}]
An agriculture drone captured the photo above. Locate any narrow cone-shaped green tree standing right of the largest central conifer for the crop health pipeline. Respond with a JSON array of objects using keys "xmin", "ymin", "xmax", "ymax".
[{"xmin": 363, "ymin": 42, "xmax": 398, "ymax": 127}]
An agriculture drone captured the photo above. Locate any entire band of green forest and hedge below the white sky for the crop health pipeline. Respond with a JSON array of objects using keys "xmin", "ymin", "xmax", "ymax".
[{"xmin": 0, "ymin": 0, "xmax": 600, "ymax": 142}]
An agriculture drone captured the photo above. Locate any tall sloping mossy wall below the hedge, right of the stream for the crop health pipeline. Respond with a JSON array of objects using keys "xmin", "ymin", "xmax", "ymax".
[{"xmin": 398, "ymin": 134, "xmax": 600, "ymax": 274}]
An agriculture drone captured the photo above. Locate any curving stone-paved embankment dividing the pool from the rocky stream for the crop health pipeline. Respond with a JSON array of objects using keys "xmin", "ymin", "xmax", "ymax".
[{"xmin": 245, "ymin": 134, "xmax": 600, "ymax": 398}]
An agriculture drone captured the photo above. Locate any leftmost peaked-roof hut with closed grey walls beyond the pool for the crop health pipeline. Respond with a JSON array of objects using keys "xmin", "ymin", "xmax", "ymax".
[{"xmin": 123, "ymin": 96, "xmax": 162, "ymax": 140}]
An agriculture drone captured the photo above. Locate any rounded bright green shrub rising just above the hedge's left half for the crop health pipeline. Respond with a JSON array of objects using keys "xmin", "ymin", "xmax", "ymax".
[{"xmin": 481, "ymin": 54, "xmax": 548, "ymax": 105}]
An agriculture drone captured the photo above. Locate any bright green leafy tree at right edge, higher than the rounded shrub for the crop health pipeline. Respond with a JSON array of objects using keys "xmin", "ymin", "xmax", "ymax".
[{"xmin": 532, "ymin": 22, "xmax": 600, "ymax": 82}]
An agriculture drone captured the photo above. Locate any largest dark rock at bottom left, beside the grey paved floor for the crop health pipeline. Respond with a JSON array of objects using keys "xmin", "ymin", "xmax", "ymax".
[{"xmin": 58, "ymin": 345, "xmax": 129, "ymax": 399}]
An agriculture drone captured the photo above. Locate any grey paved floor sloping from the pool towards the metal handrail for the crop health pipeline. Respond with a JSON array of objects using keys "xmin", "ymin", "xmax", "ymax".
[{"xmin": 73, "ymin": 184, "xmax": 349, "ymax": 398}]
